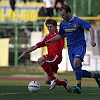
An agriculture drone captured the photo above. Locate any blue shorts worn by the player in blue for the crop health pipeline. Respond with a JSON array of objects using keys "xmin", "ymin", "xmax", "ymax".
[{"xmin": 68, "ymin": 45, "xmax": 86, "ymax": 69}]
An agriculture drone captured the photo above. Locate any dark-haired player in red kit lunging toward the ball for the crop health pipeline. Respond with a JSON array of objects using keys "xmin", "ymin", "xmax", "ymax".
[{"xmin": 18, "ymin": 19, "xmax": 72, "ymax": 92}]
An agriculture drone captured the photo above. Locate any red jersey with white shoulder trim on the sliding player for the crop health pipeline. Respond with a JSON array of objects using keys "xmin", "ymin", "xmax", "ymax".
[{"xmin": 36, "ymin": 31, "xmax": 64, "ymax": 56}]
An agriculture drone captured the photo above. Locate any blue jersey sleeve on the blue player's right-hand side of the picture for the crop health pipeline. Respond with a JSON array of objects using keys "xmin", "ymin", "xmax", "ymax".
[{"xmin": 75, "ymin": 17, "xmax": 91, "ymax": 30}]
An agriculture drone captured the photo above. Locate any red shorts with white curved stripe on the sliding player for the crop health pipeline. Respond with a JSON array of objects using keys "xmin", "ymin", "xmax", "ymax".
[{"xmin": 43, "ymin": 54, "xmax": 62, "ymax": 73}]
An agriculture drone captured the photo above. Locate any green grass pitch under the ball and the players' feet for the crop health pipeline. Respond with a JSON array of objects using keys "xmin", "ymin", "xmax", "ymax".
[{"xmin": 0, "ymin": 72, "xmax": 100, "ymax": 100}]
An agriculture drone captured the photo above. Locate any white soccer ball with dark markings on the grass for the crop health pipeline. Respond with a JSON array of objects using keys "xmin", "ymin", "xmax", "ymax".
[{"xmin": 28, "ymin": 81, "xmax": 40, "ymax": 92}]
